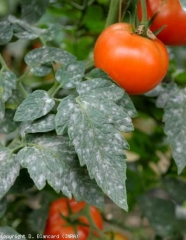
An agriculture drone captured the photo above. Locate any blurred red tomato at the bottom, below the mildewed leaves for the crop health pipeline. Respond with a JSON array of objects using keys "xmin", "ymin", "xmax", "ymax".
[{"xmin": 44, "ymin": 198, "xmax": 103, "ymax": 240}]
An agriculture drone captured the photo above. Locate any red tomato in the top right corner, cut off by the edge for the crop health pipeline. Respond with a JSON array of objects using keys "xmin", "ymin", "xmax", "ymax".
[{"xmin": 138, "ymin": 0, "xmax": 186, "ymax": 46}]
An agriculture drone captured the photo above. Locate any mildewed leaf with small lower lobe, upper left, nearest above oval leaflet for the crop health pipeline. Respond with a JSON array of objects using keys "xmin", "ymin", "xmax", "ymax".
[{"xmin": 25, "ymin": 47, "xmax": 76, "ymax": 76}]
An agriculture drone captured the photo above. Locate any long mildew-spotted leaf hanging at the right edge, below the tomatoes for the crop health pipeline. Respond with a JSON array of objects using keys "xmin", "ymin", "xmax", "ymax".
[{"xmin": 163, "ymin": 85, "xmax": 186, "ymax": 173}]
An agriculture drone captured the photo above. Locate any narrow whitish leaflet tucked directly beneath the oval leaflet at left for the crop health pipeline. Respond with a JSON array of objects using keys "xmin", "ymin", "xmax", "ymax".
[{"xmin": 25, "ymin": 114, "xmax": 55, "ymax": 133}]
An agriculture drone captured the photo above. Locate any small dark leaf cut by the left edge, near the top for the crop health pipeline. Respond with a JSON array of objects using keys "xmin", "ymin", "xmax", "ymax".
[{"xmin": 0, "ymin": 21, "xmax": 13, "ymax": 45}]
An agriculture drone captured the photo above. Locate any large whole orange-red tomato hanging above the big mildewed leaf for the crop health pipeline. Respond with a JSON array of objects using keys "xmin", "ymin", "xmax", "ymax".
[{"xmin": 94, "ymin": 23, "xmax": 169, "ymax": 94}]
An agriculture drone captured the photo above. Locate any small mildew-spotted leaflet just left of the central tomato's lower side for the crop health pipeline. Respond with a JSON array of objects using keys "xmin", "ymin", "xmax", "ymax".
[{"xmin": 56, "ymin": 62, "xmax": 85, "ymax": 89}]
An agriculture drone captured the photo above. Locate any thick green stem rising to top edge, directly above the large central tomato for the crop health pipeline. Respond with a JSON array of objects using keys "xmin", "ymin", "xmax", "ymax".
[{"xmin": 105, "ymin": 0, "xmax": 120, "ymax": 28}]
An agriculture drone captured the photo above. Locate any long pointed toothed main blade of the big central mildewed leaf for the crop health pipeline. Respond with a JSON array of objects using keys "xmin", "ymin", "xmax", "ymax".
[{"xmin": 69, "ymin": 108, "xmax": 127, "ymax": 209}]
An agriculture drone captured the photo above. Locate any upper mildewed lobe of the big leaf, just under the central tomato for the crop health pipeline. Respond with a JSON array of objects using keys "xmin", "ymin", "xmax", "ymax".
[{"xmin": 77, "ymin": 78, "xmax": 124, "ymax": 101}]
